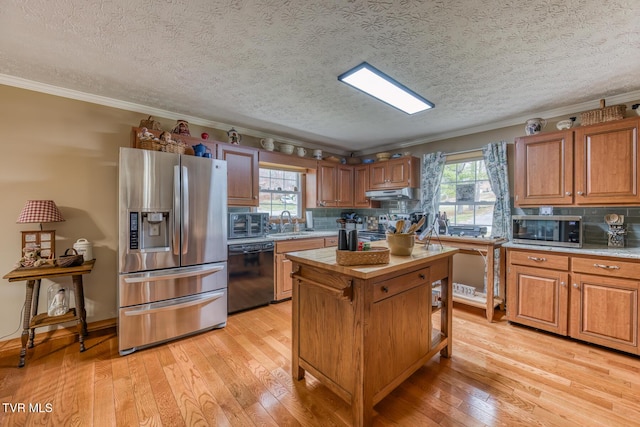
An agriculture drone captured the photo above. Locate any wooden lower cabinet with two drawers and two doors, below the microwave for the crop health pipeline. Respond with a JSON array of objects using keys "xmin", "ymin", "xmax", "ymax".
[{"xmin": 507, "ymin": 249, "xmax": 640, "ymax": 354}]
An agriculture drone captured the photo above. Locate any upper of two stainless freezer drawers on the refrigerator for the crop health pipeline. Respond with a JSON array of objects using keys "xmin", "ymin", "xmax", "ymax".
[{"xmin": 118, "ymin": 262, "xmax": 227, "ymax": 308}]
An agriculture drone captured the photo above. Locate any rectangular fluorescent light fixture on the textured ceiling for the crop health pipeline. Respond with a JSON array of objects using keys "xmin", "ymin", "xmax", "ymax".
[{"xmin": 338, "ymin": 62, "xmax": 435, "ymax": 114}]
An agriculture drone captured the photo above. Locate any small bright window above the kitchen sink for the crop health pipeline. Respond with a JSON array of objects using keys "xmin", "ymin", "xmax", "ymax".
[{"xmin": 258, "ymin": 168, "xmax": 302, "ymax": 218}]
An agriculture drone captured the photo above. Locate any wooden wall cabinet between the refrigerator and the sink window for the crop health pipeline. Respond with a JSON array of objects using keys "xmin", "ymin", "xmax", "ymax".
[{"xmin": 217, "ymin": 143, "xmax": 260, "ymax": 206}]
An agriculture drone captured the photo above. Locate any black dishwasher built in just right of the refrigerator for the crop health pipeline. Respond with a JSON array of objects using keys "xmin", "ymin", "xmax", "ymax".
[{"xmin": 227, "ymin": 241, "xmax": 274, "ymax": 313}]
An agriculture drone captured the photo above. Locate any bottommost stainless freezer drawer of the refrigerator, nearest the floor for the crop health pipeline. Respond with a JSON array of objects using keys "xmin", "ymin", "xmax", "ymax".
[{"xmin": 118, "ymin": 288, "xmax": 227, "ymax": 355}]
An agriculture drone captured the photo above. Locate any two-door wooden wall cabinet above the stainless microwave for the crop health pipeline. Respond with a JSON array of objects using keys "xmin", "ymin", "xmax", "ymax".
[{"xmin": 514, "ymin": 117, "xmax": 640, "ymax": 207}]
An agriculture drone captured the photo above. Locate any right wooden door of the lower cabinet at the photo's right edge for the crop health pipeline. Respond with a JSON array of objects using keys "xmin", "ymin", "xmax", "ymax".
[{"xmin": 570, "ymin": 274, "xmax": 640, "ymax": 354}]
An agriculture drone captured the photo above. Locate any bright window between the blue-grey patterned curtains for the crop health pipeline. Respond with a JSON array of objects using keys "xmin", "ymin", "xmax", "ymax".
[{"xmin": 438, "ymin": 156, "xmax": 496, "ymax": 235}]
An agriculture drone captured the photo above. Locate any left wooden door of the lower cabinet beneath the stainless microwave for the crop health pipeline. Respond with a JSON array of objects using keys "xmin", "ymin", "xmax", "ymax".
[{"xmin": 507, "ymin": 265, "xmax": 569, "ymax": 335}]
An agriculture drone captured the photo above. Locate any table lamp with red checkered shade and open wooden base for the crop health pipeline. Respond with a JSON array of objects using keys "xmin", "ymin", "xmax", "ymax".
[{"xmin": 16, "ymin": 200, "xmax": 64, "ymax": 258}]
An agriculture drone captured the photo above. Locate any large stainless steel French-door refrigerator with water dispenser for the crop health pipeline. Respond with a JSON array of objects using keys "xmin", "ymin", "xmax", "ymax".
[{"xmin": 118, "ymin": 148, "xmax": 228, "ymax": 355}]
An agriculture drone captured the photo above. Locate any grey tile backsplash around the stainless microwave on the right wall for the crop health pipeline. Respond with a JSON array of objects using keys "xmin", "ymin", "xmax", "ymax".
[{"xmin": 511, "ymin": 206, "xmax": 640, "ymax": 248}]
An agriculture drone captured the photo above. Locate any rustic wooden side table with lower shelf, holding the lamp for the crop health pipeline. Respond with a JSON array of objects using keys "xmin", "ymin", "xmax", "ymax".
[{"xmin": 3, "ymin": 260, "xmax": 95, "ymax": 368}]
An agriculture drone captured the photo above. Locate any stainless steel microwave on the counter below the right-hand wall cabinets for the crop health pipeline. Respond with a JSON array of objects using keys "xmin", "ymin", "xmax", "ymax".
[{"xmin": 512, "ymin": 215, "xmax": 583, "ymax": 248}]
